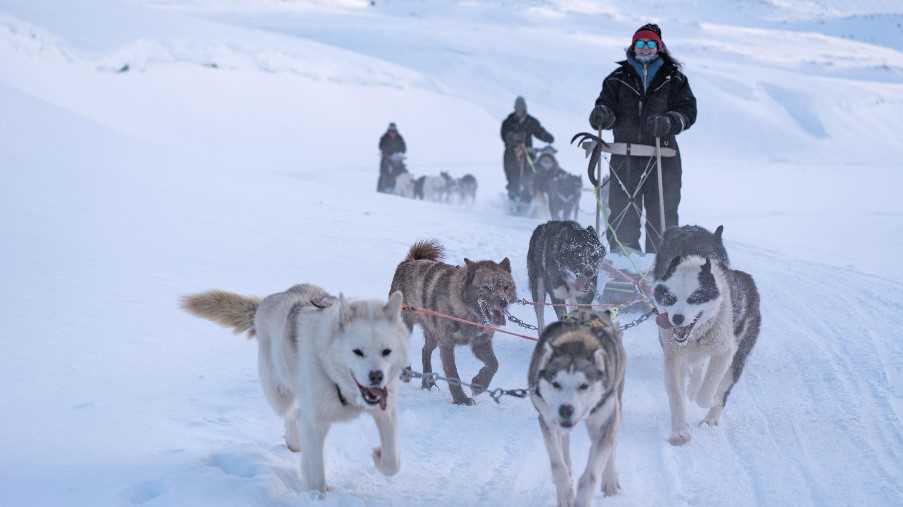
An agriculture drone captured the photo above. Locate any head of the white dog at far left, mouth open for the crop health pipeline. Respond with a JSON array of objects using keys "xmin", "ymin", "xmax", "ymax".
[{"xmin": 325, "ymin": 291, "xmax": 409, "ymax": 410}]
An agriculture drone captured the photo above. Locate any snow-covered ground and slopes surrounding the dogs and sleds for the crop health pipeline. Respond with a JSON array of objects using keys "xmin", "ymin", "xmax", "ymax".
[{"xmin": 0, "ymin": 0, "xmax": 903, "ymax": 506}]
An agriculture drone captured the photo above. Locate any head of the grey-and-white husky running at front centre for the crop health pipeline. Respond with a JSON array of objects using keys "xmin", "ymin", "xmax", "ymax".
[{"xmin": 535, "ymin": 312, "xmax": 617, "ymax": 430}]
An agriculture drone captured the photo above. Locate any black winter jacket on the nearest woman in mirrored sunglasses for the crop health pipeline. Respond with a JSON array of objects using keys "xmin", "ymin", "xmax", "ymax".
[{"xmin": 596, "ymin": 60, "xmax": 696, "ymax": 148}]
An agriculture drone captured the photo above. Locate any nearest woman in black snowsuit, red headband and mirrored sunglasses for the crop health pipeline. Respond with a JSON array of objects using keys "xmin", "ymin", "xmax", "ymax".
[{"xmin": 589, "ymin": 24, "xmax": 696, "ymax": 253}]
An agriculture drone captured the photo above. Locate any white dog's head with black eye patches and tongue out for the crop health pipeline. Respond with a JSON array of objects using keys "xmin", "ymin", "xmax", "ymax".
[{"xmin": 653, "ymin": 255, "xmax": 725, "ymax": 344}]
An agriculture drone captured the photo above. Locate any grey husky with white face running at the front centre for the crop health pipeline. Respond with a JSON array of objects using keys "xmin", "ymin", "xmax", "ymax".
[{"xmin": 527, "ymin": 309, "xmax": 626, "ymax": 507}]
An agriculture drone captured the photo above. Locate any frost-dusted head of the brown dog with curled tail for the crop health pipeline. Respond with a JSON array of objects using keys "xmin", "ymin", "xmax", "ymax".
[{"xmin": 463, "ymin": 257, "xmax": 517, "ymax": 326}]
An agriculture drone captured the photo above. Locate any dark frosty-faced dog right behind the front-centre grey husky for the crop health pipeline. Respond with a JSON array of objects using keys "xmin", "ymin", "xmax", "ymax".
[{"xmin": 527, "ymin": 220, "xmax": 605, "ymax": 332}]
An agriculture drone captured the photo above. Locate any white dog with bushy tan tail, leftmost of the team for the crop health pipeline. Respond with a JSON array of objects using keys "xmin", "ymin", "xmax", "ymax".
[{"xmin": 182, "ymin": 284, "xmax": 409, "ymax": 492}]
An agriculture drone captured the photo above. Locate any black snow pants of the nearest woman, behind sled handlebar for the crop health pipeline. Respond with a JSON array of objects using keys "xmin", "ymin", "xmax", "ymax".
[{"xmin": 608, "ymin": 153, "xmax": 681, "ymax": 253}]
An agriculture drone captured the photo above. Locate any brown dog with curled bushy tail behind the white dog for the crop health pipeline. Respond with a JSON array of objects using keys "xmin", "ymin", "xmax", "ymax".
[{"xmin": 390, "ymin": 241, "xmax": 516, "ymax": 405}]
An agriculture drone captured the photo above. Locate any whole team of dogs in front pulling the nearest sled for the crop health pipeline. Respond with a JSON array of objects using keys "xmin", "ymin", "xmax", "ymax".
[{"xmin": 182, "ymin": 221, "xmax": 761, "ymax": 506}]
